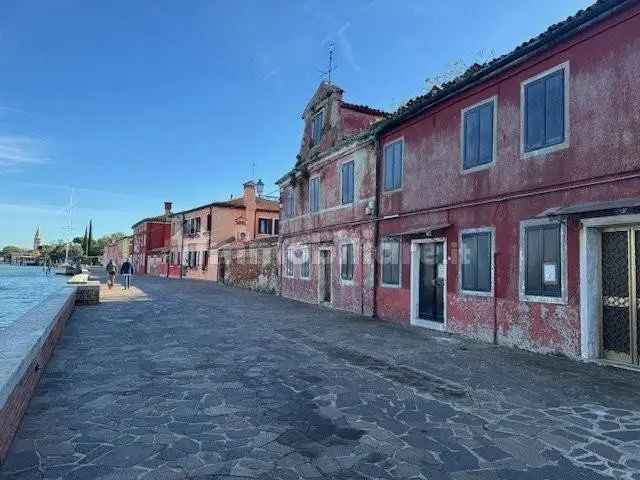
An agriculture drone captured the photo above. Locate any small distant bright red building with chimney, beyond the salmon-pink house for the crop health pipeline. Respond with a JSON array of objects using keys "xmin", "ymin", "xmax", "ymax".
[{"xmin": 131, "ymin": 202, "xmax": 171, "ymax": 274}]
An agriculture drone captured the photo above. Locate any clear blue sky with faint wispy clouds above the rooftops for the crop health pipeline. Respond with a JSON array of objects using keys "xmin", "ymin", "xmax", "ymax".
[{"xmin": 0, "ymin": 0, "xmax": 591, "ymax": 247}]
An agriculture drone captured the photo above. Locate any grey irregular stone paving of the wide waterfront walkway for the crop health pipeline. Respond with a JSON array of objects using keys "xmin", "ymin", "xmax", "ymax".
[{"xmin": 0, "ymin": 277, "xmax": 640, "ymax": 480}]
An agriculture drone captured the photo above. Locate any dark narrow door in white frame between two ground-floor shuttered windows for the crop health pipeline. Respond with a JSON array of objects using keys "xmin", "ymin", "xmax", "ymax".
[{"xmin": 418, "ymin": 242, "xmax": 445, "ymax": 323}]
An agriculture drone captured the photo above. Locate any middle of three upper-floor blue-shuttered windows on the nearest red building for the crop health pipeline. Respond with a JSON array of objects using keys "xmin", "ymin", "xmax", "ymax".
[{"xmin": 462, "ymin": 100, "xmax": 495, "ymax": 170}]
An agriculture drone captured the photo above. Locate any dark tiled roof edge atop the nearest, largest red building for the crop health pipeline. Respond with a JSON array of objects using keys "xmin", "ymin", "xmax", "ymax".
[{"xmin": 378, "ymin": 0, "xmax": 638, "ymax": 131}]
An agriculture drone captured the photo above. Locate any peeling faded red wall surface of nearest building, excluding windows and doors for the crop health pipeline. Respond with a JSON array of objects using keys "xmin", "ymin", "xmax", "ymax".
[{"xmin": 376, "ymin": 3, "xmax": 640, "ymax": 356}]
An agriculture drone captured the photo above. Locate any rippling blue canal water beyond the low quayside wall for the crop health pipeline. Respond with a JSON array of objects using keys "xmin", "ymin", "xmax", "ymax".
[{"xmin": 0, "ymin": 263, "xmax": 68, "ymax": 328}]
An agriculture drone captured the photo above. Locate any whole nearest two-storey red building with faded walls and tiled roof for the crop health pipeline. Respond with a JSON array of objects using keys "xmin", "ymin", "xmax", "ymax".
[{"xmin": 375, "ymin": 1, "xmax": 640, "ymax": 364}]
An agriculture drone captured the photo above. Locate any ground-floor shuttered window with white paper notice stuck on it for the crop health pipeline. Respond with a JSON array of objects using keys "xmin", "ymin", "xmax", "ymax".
[{"xmin": 524, "ymin": 223, "xmax": 562, "ymax": 297}]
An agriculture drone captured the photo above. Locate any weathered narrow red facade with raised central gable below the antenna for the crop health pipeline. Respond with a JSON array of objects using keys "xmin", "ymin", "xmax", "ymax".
[{"xmin": 278, "ymin": 82, "xmax": 386, "ymax": 315}]
